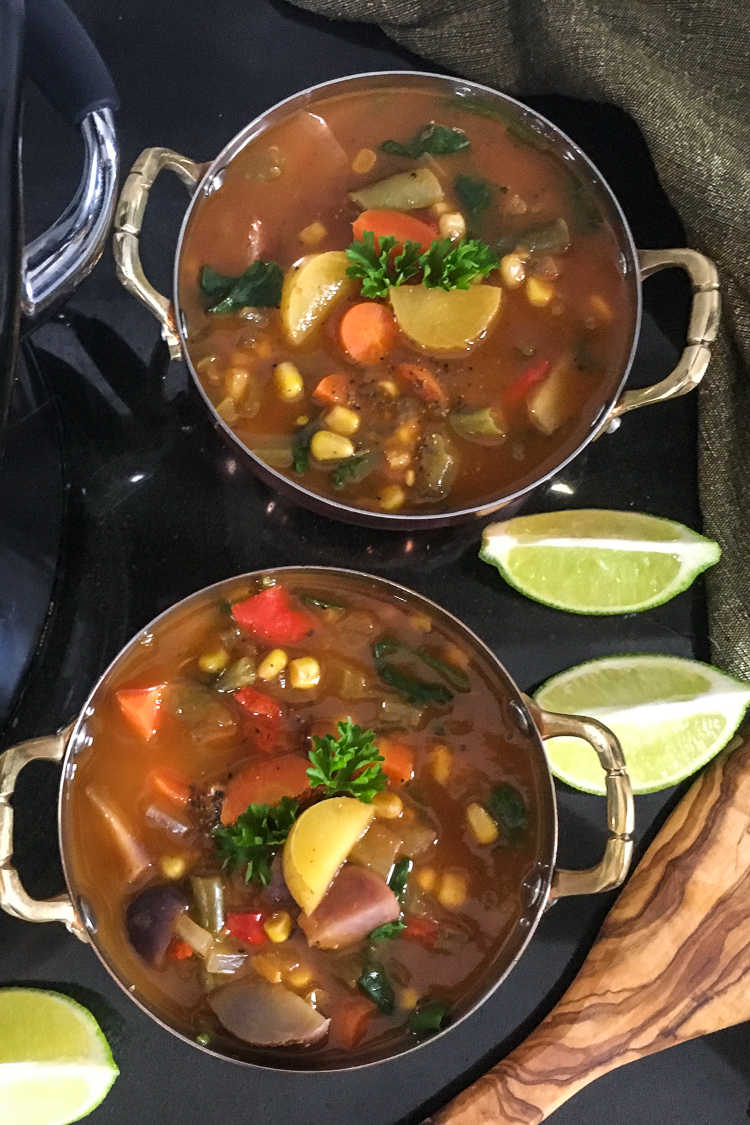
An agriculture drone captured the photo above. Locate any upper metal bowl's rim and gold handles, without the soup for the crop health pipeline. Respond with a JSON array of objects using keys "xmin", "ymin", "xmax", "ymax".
[{"xmin": 114, "ymin": 71, "xmax": 719, "ymax": 530}]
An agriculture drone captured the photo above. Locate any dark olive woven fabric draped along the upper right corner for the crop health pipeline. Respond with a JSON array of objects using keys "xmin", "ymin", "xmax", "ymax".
[{"xmin": 296, "ymin": 0, "xmax": 750, "ymax": 677}]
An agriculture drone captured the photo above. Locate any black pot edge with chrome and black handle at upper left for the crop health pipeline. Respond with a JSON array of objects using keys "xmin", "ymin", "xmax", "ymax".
[{"xmin": 0, "ymin": 0, "xmax": 119, "ymax": 441}]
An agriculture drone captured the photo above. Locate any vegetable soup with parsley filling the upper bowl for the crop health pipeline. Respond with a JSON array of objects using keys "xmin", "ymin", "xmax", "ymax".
[{"xmin": 179, "ymin": 79, "xmax": 634, "ymax": 515}]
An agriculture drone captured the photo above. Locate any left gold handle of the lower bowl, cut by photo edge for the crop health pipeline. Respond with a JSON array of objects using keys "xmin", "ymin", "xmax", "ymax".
[{"xmin": 0, "ymin": 727, "xmax": 88, "ymax": 942}]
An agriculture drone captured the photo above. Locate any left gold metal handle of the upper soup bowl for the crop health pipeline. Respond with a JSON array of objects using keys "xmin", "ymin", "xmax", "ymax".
[{"xmin": 112, "ymin": 149, "xmax": 207, "ymax": 359}]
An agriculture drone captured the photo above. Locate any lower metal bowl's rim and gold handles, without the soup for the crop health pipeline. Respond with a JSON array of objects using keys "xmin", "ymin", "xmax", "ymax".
[{"xmin": 0, "ymin": 567, "xmax": 633, "ymax": 1071}]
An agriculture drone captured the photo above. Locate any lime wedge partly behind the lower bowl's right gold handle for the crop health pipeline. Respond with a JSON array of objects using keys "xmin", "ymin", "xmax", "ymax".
[{"xmin": 534, "ymin": 654, "xmax": 750, "ymax": 794}]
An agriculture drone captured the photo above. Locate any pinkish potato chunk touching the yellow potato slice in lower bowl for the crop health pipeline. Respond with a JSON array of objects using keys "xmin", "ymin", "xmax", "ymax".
[{"xmin": 299, "ymin": 863, "xmax": 401, "ymax": 950}]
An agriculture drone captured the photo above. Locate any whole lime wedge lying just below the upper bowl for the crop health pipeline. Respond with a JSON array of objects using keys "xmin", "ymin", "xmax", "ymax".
[{"xmin": 479, "ymin": 509, "xmax": 721, "ymax": 613}]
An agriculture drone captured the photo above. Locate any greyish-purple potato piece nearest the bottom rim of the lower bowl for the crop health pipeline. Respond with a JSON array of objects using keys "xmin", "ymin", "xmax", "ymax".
[{"xmin": 208, "ymin": 977, "xmax": 331, "ymax": 1047}]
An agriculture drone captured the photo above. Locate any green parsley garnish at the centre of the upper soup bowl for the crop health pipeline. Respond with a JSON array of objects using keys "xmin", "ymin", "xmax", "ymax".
[{"xmin": 346, "ymin": 231, "xmax": 498, "ymax": 298}]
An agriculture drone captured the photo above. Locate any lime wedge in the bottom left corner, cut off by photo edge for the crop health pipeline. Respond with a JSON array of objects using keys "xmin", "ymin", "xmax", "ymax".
[{"xmin": 0, "ymin": 988, "xmax": 119, "ymax": 1125}]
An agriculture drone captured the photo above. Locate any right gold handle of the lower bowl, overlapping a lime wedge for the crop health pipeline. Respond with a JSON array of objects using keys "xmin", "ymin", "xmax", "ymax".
[{"xmin": 525, "ymin": 698, "xmax": 635, "ymax": 901}]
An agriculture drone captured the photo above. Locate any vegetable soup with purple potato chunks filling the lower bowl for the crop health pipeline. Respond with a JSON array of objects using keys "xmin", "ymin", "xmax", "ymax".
[{"xmin": 63, "ymin": 569, "xmax": 553, "ymax": 1068}]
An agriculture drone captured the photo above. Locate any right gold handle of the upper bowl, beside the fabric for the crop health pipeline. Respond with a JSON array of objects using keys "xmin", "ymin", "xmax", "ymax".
[{"xmin": 607, "ymin": 250, "xmax": 721, "ymax": 423}]
